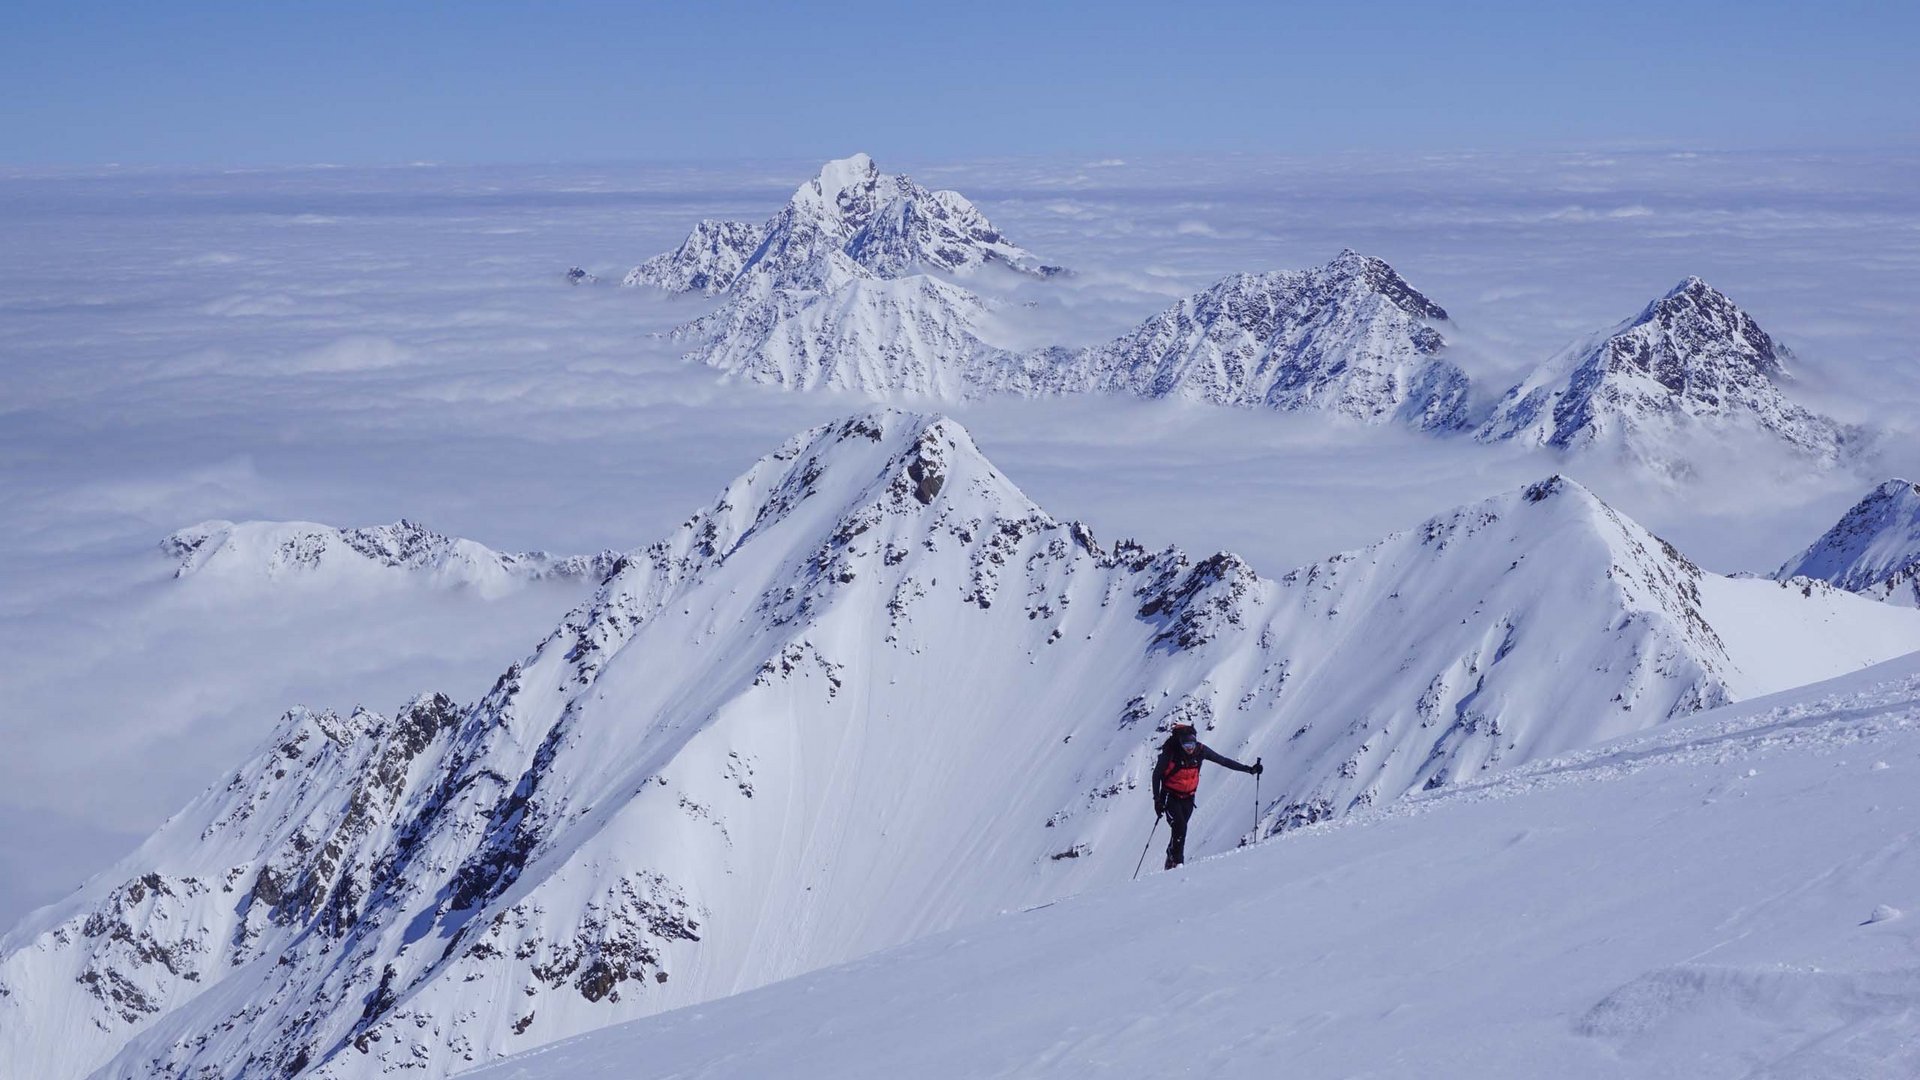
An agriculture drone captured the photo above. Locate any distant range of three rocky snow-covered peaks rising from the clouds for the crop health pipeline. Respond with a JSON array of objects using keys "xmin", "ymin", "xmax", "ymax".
[{"xmin": 599, "ymin": 154, "xmax": 1866, "ymax": 463}]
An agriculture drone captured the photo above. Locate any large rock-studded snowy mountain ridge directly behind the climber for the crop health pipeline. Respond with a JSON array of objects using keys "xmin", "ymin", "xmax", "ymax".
[{"xmin": 0, "ymin": 411, "xmax": 1920, "ymax": 1078}]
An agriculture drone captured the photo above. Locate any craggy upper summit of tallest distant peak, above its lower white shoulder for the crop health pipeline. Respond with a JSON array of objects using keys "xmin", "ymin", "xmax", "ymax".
[{"xmin": 626, "ymin": 154, "xmax": 1060, "ymax": 294}]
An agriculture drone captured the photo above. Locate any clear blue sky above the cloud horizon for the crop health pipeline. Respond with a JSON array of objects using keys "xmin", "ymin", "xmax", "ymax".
[{"xmin": 0, "ymin": 0, "xmax": 1920, "ymax": 165}]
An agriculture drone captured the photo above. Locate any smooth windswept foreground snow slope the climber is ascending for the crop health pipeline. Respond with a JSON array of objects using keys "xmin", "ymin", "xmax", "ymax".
[{"xmin": 470, "ymin": 655, "xmax": 1920, "ymax": 1080}]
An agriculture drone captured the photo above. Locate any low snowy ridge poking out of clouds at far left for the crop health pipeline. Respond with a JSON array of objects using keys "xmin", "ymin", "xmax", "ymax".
[{"xmin": 159, "ymin": 519, "xmax": 618, "ymax": 594}]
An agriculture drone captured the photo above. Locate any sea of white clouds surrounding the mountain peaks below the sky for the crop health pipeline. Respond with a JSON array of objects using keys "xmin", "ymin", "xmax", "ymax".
[{"xmin": 0, "ymin": 148, "xmax": 1920, "ymax": 926}]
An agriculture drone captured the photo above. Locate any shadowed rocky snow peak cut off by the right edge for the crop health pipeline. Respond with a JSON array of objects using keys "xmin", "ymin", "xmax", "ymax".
[{"xmin": 1774, "ymin": 480, "xmax": 1920, "ymax": 607}]
